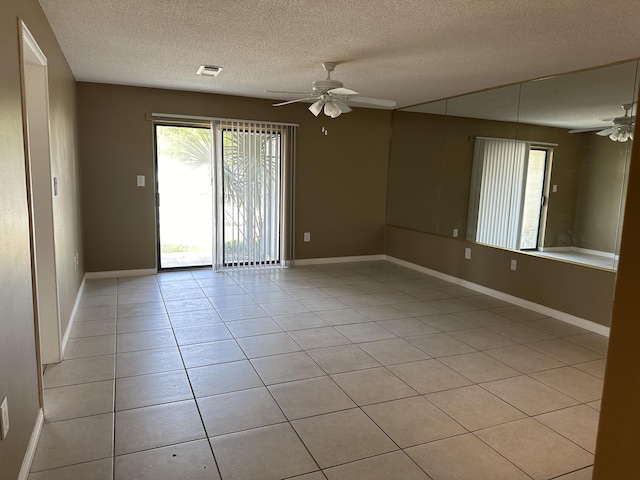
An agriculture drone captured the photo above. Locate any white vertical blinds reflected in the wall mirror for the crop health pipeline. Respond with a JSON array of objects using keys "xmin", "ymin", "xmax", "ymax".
[{"xmin": 470, "ymin": 138, "xmax": 528, "ymax": 249}]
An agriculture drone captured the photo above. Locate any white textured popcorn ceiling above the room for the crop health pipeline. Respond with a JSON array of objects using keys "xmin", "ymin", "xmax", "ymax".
[{"xmin": 40, "ymin": 0, "xmax": 640, "ymax": 108}]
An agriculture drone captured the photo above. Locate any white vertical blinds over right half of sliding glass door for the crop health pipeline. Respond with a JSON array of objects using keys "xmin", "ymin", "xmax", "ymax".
[{"xmin": 212, "ymin": 121, "xmax": 295, "ymax": 268}]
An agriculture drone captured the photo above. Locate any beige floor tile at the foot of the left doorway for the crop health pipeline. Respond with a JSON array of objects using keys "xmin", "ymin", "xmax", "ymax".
[{"xmin": 43, "ymin": 355, "xmax": 115, "ymax": 388}]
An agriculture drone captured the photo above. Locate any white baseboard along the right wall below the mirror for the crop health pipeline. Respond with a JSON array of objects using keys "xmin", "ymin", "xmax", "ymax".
[{"xmin": 386, "ymin": 255, "xmax": 609, "ymax": 337}]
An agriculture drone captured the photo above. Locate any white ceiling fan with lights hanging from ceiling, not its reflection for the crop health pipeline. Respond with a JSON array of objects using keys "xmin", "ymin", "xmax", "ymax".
[{"xmin": 269, "ymin": 62, "xmax": 396, "ymax": 118}]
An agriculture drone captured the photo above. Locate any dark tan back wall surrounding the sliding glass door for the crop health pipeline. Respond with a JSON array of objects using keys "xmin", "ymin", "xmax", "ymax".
[{"xmin": 77, "ymin": 83, "xmax": 391, "ymax": 271}]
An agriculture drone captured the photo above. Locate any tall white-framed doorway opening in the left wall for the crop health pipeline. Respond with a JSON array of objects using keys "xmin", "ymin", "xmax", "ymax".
[{"xmin": 20, "ymin": 21, "xmax": 62, "ymax": 365}]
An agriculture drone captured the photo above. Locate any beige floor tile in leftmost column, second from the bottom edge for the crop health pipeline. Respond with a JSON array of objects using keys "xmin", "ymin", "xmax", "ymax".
[{"xmin": 31, "ymin": 413, "xmax": 113, "ymax": 472}]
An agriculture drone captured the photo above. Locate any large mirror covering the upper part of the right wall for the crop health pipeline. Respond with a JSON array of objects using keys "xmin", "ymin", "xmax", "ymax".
[{"xmin": 387, "ymin": 61, "xmax": 638, "ymax": 269}]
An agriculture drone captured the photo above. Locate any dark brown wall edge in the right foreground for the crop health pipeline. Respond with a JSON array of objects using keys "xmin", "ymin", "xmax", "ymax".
[{"xmin": 593, "ymin": 113, "xmax": 640, "ymax": 480}]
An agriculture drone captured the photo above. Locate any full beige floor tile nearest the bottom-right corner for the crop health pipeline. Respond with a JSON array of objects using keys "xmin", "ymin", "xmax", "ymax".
[{"xmin": 476, "ymin": 418, "xmax": 593, "ymax": 479}]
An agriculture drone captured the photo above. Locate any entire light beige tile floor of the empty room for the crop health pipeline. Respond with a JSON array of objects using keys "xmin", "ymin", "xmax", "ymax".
[{"xmin": 29, "ymin": 261, "xmax": 607, "ymax": 480}]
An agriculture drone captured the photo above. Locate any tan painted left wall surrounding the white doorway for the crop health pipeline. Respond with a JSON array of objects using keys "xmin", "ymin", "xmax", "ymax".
[{"xmin": 0, "ymin": 0, "xmax": 83, "ymax": 480}]
